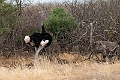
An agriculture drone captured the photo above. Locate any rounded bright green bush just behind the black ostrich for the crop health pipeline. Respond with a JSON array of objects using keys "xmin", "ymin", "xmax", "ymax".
[{"xmin": 45, "ymin": 8, "xmax": 76, "ymax": 38}]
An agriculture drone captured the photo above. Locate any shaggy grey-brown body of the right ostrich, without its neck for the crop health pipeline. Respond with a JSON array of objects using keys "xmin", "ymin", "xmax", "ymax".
[{"xmin": 93, "ymin": 41, "xmax": 119, "ymax": 61}]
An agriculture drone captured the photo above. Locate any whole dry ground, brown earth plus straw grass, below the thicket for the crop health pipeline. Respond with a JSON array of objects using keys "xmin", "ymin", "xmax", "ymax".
[{"xmin": 0, "ymin": 53, "xmax": 120, "ymax": 80}]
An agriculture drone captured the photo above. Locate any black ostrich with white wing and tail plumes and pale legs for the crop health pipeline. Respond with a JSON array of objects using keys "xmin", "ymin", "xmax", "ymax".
[{"xmin": 24, "ymin": 24, "xmax": 52, "ymax": 61}]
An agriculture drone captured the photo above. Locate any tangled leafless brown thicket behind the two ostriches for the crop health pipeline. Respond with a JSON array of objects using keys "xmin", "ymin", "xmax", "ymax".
[{"xmin": 0, "ymin": 0, "xmax": 120, "ymax": 55}]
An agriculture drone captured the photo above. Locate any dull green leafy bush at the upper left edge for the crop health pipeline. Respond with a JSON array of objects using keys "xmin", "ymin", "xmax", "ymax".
[{"xmin": 0, "ymin": 0, "xmax": 18, "ymax": 34}]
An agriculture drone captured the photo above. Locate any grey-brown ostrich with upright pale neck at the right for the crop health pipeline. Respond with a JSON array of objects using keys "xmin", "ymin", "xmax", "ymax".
[{"xmin": 88, "ymin": 23, "xmax": 120, "ymax": 62}]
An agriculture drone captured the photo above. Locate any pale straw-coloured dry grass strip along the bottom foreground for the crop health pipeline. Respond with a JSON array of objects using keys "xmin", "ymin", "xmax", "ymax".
[{"xmin": 0, "ymin": 53, "xmax": 120, "ymax": 80}]
